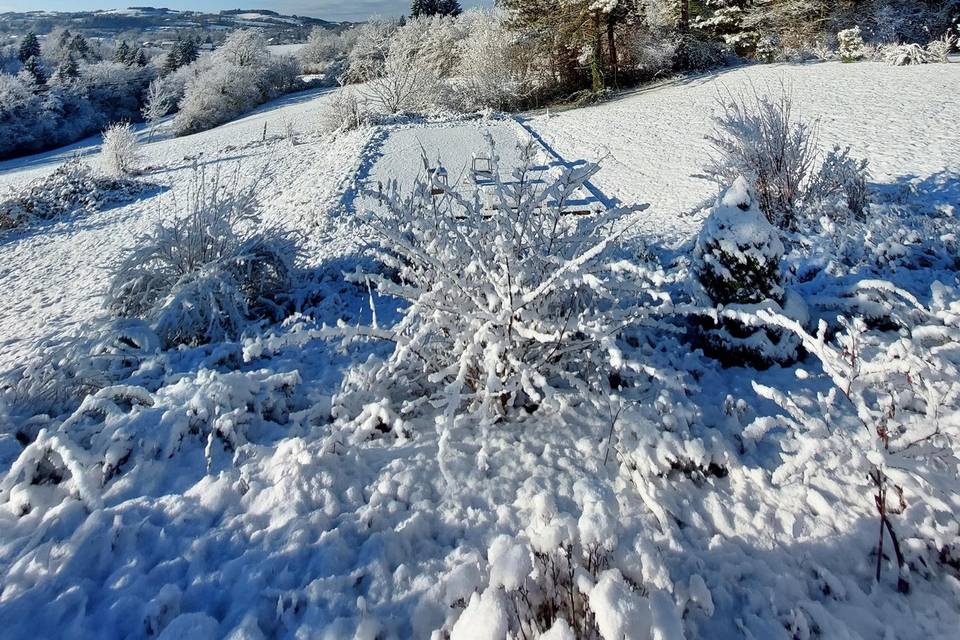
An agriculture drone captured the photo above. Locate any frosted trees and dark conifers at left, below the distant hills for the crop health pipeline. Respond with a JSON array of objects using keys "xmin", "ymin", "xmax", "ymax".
[{"xmin": 0, "ymin": 30, "xmax": 301, "ymax": 158}]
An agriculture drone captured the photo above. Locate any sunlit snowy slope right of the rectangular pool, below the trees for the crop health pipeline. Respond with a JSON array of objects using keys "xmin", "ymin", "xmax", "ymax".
[{"xmin": 527, "ymin": 62, "xmax": 960, "ymax": 244}]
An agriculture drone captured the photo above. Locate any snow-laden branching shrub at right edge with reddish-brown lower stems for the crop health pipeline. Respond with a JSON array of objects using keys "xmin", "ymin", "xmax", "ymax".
[{"xmin": 743, "ymin": 282, "xmax": 960, "ymax": 592}]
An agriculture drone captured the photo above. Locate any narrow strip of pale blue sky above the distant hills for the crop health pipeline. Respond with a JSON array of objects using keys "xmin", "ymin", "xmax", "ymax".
[{"xmin": 0, "ymin": 0, "xmax": 493, "ymax": 20}]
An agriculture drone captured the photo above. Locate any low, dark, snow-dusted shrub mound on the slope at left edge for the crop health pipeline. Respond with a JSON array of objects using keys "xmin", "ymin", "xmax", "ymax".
[{"xmin": 0, "ymin": 157, "xmax": 151, "ymax": 229}]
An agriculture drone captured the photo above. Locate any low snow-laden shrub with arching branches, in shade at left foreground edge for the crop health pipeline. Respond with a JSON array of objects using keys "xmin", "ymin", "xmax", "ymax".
[{"xmin": 0, "ymin": 369, "xmax": 300, "ymax": 516}]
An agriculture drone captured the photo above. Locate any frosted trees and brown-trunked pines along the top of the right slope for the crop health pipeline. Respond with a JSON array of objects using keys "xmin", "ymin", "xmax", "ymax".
[{"xmin": 299, "ymin": 0, "xmax": 960, "ymax": 122}]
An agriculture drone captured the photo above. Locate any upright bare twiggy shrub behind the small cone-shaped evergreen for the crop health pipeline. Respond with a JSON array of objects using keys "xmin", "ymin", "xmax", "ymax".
[{"xmin": 705, "ymin": 91, "xmax": 816, "ymax": 229}]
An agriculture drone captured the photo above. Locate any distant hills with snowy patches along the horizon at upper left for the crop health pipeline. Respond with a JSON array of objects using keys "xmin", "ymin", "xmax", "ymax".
[{"xmin": 0, "ymin": 6, "xmax": 349, "ymax": 44}]
